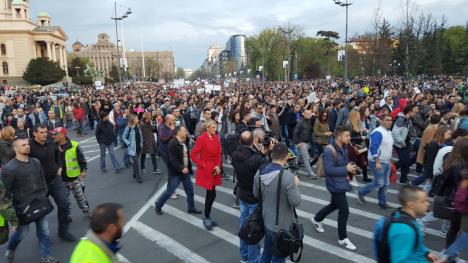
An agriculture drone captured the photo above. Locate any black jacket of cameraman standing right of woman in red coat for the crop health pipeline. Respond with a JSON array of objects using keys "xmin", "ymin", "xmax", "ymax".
[{"xmin": 232, "ymin": 145, "xmax": 268, "ymax": 204}]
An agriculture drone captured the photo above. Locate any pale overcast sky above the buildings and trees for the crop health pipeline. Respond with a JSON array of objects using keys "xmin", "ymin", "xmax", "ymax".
[{"xmin": 30, "ymin": 0, "xmax": 468, "ymax": 69}]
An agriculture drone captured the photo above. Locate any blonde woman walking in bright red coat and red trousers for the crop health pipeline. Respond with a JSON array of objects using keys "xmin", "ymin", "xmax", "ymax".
[{"xmin": 190, "ymin": 120, "xmax": 222, "ymax": 230}]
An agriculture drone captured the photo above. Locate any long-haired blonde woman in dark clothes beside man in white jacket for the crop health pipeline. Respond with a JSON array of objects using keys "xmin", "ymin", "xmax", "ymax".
[{"xmin": 346, "ymin": 110, "xmax": 370, "ymax": 186}]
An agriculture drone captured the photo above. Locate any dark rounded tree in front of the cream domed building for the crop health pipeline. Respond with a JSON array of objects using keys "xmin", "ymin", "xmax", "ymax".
[{"xmin": 23, "ymin": 58, "xmax": 65, "ymax": 86}]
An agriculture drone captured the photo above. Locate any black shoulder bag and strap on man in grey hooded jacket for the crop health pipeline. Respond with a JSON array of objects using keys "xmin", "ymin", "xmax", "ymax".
[{"xmin": 273, "ymin": 170, "xmax": 304, "ymax": 262}]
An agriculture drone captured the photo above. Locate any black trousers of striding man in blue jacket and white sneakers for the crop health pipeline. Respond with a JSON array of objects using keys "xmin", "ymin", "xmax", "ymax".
[{"xmin": 314, "ymin": 193, "xmax": 349, "ymax": 240}]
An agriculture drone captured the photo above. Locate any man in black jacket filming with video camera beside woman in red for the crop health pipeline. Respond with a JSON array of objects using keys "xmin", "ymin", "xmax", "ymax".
[{"xmin": 232, "ymin": 131, "xmax": 269, "ymax": 263}]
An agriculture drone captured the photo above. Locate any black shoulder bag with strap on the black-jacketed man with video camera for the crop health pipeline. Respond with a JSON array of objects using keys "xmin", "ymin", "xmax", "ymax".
[{"xmin": 237, "ymin": 176, "xmax": 265, "ymax": 245}]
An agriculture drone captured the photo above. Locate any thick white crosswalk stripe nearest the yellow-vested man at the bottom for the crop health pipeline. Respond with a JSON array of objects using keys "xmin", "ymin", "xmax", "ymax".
[{"xmin": 133, "ymin": 222, "xmax": 209, "ymax": 263}]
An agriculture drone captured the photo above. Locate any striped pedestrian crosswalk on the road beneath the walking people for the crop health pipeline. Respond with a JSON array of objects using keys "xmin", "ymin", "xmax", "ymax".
[{"xmin": 117, "ymin": 165, "xmax": 466, "ymax": 262}]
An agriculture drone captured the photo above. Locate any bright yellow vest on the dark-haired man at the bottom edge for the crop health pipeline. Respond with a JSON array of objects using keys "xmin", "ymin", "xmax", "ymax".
[{"xmin": 70, "ymin": 239, "xmax": 112, "ymax": 263}]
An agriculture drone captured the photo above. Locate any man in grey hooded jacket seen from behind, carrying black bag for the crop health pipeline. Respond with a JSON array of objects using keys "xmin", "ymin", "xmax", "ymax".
[{"xmin": 253, "ymin": 143, "xmax": 301, "ymax": 262}]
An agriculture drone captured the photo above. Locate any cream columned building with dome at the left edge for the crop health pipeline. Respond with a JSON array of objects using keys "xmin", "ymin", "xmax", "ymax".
[{"xmin": 0, "ymin": 0, "xmax": 68, "ymax": 85}]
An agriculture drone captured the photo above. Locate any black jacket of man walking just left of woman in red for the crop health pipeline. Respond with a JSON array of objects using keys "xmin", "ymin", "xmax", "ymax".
[{"xmin": 167, "ymin": 137, "xmax": 192, "ymax": 176}]
